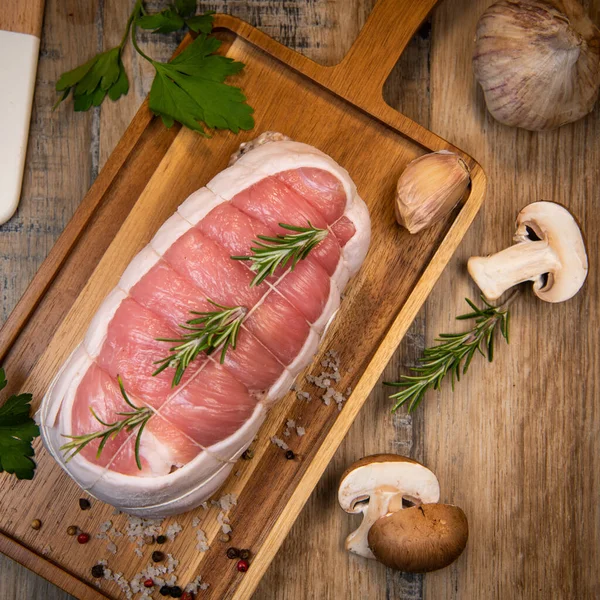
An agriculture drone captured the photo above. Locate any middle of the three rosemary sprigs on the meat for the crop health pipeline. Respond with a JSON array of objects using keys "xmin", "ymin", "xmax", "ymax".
[{"xmin": 152, "ymin": 299, "xmax": 248, "ymax": 387}]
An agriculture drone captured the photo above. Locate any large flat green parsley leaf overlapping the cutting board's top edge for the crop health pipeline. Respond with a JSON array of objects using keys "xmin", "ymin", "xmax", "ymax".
[{"xmin": 149, "ymin": 35, "xmax": 254, "ymax": 134}]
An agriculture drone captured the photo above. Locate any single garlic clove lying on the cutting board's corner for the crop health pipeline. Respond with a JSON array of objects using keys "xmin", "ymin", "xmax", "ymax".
[{"xmin": 396, "ymin": 150, "xmax": 471, "ymax": 234}]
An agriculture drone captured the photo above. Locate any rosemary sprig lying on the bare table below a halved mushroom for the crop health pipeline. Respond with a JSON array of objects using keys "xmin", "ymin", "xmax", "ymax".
[{"xmin": 385, "ymin": 293, "xmax": 516, "ymax": 412}]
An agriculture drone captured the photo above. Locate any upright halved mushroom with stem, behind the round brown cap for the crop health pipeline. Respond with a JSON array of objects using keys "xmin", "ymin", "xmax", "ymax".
[{"xmin": 338, "ymin": 454, "xmax": 440, "ymax": 558}]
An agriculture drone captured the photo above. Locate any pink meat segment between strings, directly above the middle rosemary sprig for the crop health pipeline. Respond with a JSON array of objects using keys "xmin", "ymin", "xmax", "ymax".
[{"xmin": 130, "ymin": 260, "xmax": 215, "ymax": 333}]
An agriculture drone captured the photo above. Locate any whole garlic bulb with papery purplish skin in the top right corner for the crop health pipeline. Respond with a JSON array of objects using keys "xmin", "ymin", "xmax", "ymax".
[{"xmin": 473, "ymin": 0, "xmax": 600, "ymax": 131}]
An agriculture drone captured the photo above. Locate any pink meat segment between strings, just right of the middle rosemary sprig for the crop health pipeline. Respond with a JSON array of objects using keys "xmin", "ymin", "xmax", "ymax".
[{"xmin": 245, "ymin": 292, "xmax": 310, "ymax": 366}]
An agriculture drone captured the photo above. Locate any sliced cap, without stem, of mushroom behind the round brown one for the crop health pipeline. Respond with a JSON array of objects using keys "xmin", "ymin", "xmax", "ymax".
[{"xmin": 338, "ymin": 454, "xmax": 440, "ymax": 513}]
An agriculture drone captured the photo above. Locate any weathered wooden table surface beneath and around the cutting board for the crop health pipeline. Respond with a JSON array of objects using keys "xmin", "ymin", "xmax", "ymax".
[{"xmin": 0, "ymin": 0, "xmax": 600, "ymax": 600}]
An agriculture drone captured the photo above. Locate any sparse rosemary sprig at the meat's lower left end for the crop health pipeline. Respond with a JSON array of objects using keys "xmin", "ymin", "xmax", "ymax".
[{"xmin": 60, "ymin": 377, "xmax": 154, "ymax": 471}]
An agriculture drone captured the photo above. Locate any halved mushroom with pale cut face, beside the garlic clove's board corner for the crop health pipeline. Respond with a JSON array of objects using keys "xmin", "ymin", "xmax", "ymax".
[{"xmin": 468, "ymin": 202, "xmax": 588, "ymax": 302}]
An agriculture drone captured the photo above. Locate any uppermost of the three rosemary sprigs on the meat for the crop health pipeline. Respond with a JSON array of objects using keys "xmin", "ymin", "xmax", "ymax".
[{"xmin": 231, "ymin": 221, "xmax": 328, "ymax": 287}]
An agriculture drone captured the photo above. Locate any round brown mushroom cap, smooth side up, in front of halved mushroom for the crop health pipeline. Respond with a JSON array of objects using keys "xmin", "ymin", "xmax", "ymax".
[{"xmin": 368, "ymin": 504, "xmax": 469, "ymax": 573}]
